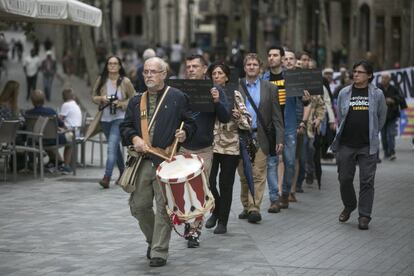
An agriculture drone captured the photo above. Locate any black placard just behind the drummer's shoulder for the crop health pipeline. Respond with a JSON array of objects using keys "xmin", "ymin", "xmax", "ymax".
[{"xmin": 167, "ymin": 79, "xmax": 214, "ymax": 112}]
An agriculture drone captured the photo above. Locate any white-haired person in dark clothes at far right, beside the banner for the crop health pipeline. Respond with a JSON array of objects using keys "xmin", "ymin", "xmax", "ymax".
[{"xmin": 378, "ymin": 72, "xmax": 402, "ymax": 161}]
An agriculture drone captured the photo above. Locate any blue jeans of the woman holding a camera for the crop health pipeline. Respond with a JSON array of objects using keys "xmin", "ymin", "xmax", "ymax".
[{"xmin": 101, "ymin": 119, "xmax": 125, "ymax": 178}]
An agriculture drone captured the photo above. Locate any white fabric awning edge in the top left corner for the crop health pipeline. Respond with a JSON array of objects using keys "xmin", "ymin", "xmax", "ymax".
[{"xmin": 0, "ymin": 0, "xmax": 102, "ymax": 27}]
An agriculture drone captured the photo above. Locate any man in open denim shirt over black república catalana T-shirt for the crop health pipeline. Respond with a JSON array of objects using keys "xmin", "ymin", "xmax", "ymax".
[{"xmin": 331, "ymin": 60, "xmax": 387, "ymax": 230}]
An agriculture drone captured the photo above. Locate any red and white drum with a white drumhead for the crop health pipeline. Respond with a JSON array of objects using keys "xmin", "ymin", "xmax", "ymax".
[{"xmin": 157, "ymin": 154, "xmax": 214, "ymax": 222}]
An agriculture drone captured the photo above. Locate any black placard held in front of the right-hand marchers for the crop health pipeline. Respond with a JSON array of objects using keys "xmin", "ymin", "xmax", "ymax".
[{"xmin": 284, "ymin": 69, "xmax": 323, "ymax": 97}]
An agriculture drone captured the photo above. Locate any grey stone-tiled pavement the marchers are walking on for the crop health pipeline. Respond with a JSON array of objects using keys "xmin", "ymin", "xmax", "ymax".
[{"xmin": 0, "ymin": 140, "xmax": 414, "ymax": 276}]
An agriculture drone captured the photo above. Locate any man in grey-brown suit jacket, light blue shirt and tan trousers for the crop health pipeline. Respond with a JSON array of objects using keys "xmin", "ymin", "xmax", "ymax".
[{"xmin": 238, "ymin": 53, "xmax": 284, "ymax": 223}]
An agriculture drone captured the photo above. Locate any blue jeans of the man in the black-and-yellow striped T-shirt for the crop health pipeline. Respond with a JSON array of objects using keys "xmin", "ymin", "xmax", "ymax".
[{"xmin": 267, "ymin": 130, "xmax": 296, "ymax": 202}]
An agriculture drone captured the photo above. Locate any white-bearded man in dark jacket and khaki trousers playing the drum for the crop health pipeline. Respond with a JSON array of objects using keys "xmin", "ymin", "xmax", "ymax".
[{"xmin": 120, "ymin": 57, "xmax": 196, "ymax": 267}]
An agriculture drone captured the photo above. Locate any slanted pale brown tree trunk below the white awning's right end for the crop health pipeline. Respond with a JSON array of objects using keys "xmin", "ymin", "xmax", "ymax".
[{"xmin": 79, "ymin": 26, "xmax": 99, "ymax": 88}]
